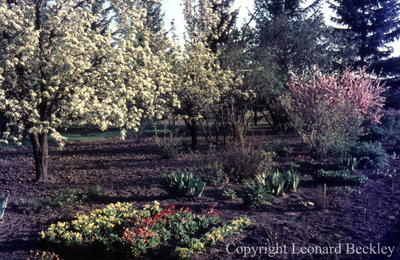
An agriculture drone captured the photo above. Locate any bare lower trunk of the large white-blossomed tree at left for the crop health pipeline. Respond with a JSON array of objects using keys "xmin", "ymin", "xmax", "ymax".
[{"xmin": 30, "ymin": 133, "xmax": 49, "ymax": 182}]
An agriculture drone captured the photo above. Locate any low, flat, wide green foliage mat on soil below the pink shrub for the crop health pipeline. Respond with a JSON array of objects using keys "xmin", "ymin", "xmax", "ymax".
[{"xmin": 313, "ymin": 169, "xmax": 368, "ymax": 185}]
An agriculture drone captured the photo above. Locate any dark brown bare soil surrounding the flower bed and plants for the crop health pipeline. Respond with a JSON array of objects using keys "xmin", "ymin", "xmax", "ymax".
[{"xmin": 0, "ymin": 136, "xmax": 400, "ymax": 259}]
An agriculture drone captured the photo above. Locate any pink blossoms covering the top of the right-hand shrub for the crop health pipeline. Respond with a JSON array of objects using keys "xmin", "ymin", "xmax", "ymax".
[{"xmin": 288, "ymin": 68, "xmax": 387, "ymax": 122}]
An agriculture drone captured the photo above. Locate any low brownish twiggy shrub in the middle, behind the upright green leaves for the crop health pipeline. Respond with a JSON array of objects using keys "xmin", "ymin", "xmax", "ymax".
[{"xmin": 223, "ymin": 145, "xmax": 274, "ymax": 182}]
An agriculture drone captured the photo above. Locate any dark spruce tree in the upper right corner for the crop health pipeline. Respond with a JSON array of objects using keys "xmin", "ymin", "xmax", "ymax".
[{"xmin": 331, "ymin": 0, "xmax": 400, "ymax": 69}]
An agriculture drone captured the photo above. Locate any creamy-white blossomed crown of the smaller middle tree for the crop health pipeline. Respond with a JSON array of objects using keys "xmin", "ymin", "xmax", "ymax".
[{"xmin": 174, "ymin": 0, "xmax": 242, "ymax": 121}]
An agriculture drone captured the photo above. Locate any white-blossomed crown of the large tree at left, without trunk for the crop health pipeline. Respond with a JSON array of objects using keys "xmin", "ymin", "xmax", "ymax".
[{"xmin": 0, "ymin": 0, "xmax": 179, "ymax": 145}]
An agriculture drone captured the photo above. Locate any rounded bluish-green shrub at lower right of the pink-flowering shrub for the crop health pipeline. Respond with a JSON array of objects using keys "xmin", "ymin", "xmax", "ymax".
[{"xmin": 350, "ymin": 141, "xmax": 389, "ymax": 169}]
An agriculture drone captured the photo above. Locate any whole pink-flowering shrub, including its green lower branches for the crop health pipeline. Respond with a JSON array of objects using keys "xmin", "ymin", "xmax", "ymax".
[{"xmin": 281, "ymin": 68, "xmax": 386, "ymax": 157}]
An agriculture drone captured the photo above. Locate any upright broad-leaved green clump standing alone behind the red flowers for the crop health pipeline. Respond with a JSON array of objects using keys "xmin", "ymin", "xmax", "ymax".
[{"xmin": 161, "ymin": 170, "xmax": 206, "ymax": 197}]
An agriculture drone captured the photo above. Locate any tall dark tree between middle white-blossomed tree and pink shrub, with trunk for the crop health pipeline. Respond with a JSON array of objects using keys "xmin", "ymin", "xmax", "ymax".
[{"xmin": 253, "ymin": 0, "xmax": 330, "ymax": 130}]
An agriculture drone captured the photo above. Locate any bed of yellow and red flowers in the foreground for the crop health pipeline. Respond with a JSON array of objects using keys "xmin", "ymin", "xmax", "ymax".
[{"xmin": 40, "ymin": 201, "xmax": 251, "ymax": 258}]
